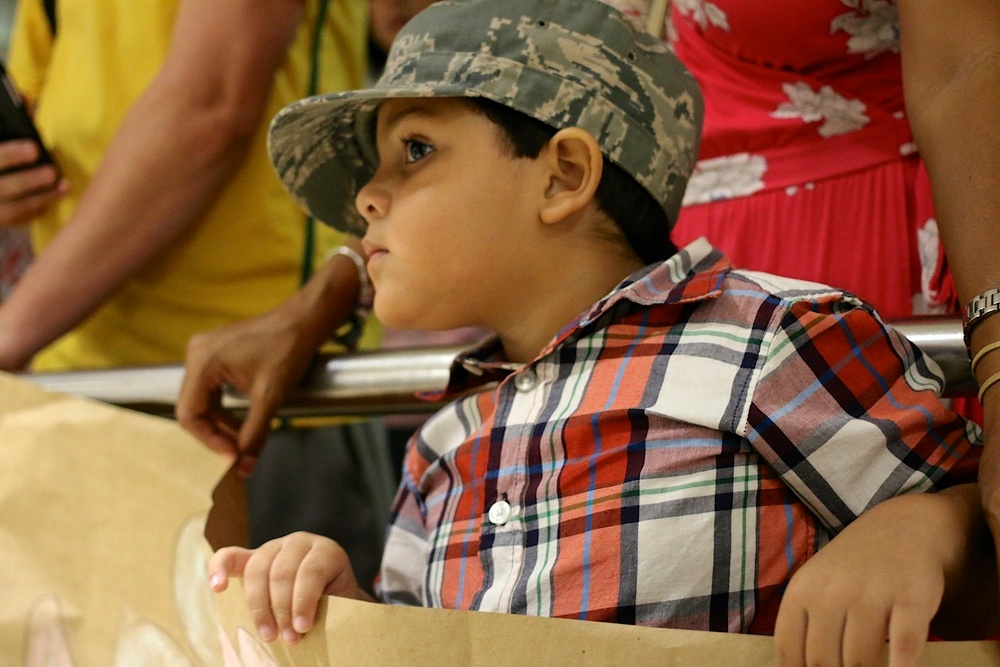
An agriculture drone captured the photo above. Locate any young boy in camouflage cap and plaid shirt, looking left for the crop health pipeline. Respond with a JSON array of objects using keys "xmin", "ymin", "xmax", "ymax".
[{"xmin": 210, "ymin": 0, "xmax": 993, "ymax": 662}]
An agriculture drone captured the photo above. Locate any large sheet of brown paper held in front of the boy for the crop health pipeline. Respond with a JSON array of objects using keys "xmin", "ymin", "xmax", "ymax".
[{"xmin": 0, "ymin": 374, "xmax": 1000, "ymax": 667}]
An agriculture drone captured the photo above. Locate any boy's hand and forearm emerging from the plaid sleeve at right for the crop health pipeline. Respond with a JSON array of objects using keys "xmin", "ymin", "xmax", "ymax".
[{"xmin": 774, "ymin": 484, "xmax": 1000, "ymax": 667}]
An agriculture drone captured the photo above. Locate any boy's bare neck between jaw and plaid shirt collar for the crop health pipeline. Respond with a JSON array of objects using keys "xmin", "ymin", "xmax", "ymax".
[{"xmin": 494, "ymin": 244, "xmax": 644, "ymax": 363}]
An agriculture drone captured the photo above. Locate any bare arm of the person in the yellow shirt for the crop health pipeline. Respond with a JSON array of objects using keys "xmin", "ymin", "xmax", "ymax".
[{"xmin": 0, "ymin": 0, "xmax": 303, "ymax": 369}]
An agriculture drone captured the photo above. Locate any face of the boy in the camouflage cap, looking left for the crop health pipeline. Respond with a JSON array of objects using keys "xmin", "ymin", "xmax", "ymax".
[{"xmin": 357, "ymin": 98, "xmax": 547, "ymax": 331}]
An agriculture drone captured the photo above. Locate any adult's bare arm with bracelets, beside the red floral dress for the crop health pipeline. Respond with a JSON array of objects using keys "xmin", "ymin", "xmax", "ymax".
[{"xmin": 899, "ymin": 0, "xmax": 1000, "ymax": 540}]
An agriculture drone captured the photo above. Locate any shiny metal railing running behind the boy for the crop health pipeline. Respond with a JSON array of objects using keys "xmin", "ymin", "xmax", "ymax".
[{"xmin": 23, "ymin": 317, "xmax": 976, "ymax": 417}]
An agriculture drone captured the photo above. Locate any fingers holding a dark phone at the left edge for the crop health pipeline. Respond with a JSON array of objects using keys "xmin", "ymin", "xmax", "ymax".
[{"xmin": 0, "ymin": 139, "xmax": 69, "ymax": 226}]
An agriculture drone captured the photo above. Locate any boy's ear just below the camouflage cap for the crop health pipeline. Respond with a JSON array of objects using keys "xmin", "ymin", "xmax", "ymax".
[{"xmin": 539, "ymin": 127, "xmax": 604, "ymax": 224}]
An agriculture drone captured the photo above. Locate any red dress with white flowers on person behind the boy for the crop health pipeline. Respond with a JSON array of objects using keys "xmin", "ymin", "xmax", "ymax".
[{"xmin": 671, "ymin": 0, "xmax": 955, "ymax": 319}]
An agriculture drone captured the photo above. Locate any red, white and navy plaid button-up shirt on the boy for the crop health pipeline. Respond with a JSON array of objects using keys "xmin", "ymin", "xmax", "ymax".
[{"xmin": 378, "ymin": 240, "xmax": 980, "ymax": 632}]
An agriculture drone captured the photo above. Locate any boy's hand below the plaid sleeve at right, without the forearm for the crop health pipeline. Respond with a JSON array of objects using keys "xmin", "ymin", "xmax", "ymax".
[{"xmin": 774, "ymin": 527, "xmax": 944, "ymax": 667}]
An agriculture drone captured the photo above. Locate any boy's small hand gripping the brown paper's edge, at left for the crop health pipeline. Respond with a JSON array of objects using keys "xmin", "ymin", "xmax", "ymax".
[{"xmin": 208, "ymin": 532, "xmax": 374, "ymax": 644}]
